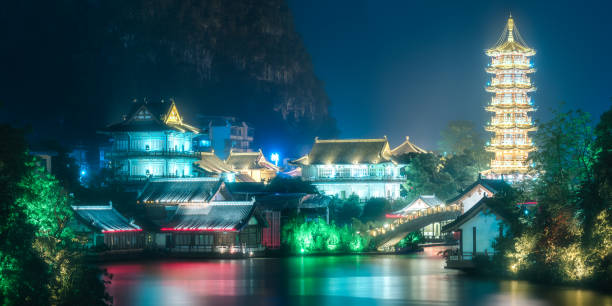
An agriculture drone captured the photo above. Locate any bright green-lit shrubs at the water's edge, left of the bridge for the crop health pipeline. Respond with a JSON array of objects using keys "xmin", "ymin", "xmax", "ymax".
[{"xmin": 282, "ymin": 218, "xmax": 369, "ymax": 254}]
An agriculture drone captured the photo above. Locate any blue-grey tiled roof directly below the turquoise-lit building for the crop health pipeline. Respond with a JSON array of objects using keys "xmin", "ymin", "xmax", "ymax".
[{"xmin": 138, "ymin": 177, "xmax": 223, "ymax": 204}]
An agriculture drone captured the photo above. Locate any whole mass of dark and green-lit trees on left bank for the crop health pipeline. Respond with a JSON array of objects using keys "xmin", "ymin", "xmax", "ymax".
[{"xmin": 0, "ymin": 125, "xmax": 111, "ymax": 305}]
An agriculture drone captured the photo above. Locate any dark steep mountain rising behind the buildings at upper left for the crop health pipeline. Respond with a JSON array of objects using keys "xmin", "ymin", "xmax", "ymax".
[{"xmin": 0, "ymin": 0, "xmax": 338, "ymax": 154}]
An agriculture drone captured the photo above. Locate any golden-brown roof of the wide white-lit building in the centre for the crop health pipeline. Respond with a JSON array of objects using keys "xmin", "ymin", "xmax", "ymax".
[{"xmin": 291, "ymin": 137, "xmax": 394, "ymax": 165}]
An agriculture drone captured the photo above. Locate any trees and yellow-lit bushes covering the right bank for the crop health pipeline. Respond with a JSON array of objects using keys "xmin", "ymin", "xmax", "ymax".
[{"xmin": 477, "ymin": 109, "xmax": 612, "ymax": 290}]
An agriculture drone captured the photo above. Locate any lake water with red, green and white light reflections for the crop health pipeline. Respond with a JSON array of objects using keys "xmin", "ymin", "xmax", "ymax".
[{"xmin": 104, "ymin": 249, "xmax": 612, "ymax": 306}]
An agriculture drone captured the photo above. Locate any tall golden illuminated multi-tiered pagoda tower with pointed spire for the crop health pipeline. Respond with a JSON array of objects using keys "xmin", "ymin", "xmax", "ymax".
[{"xmin": 485, "ymin": 15, "xmax": 536, "ymax": 179}]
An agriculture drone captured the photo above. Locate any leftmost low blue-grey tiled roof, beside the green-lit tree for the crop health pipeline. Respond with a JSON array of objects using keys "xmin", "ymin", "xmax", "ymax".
[{"xmin": 72, "ymin": 205, "xmax": 141, "ymax": 232}]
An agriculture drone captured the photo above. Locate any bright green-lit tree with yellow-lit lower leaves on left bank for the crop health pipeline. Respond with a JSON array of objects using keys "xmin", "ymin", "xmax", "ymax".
[{"xmin": 16, "ymin": 161, "xmax": 111, "ymax": 305}]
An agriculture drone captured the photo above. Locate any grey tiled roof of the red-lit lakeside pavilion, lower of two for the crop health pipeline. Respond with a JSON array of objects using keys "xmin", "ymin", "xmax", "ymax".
[{"xmin": 162, "ymin": 201, "xmax": 255, "ymax": 231}]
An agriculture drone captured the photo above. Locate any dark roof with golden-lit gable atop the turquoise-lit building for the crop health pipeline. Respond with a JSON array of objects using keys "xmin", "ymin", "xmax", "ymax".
[{"xmin": 102, "ymin": 100, "xmax": 200, "ymax": 134}]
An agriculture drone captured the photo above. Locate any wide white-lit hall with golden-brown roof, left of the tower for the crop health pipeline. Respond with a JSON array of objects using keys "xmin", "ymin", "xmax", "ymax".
[{"xmin": 291, "ymin": 137, "xmax": 404, "ymax": 200}]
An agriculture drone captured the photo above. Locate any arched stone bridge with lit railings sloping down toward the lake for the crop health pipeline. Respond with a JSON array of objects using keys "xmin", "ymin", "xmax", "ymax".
[{"xmin": 369, "ymin": 205, "xmax": 461, "ymax": 250}]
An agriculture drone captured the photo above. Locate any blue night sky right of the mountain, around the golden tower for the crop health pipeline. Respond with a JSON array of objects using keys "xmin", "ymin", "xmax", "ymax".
[{"xmin": 290, "ymin": 0, "xmax": 612, "ymax": 149}]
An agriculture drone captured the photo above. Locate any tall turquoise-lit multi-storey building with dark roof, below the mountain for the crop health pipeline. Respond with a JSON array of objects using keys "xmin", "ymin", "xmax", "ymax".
[{"xmin": 102, "ymin": 100, "xmax": 200, "ymax": 180}]
